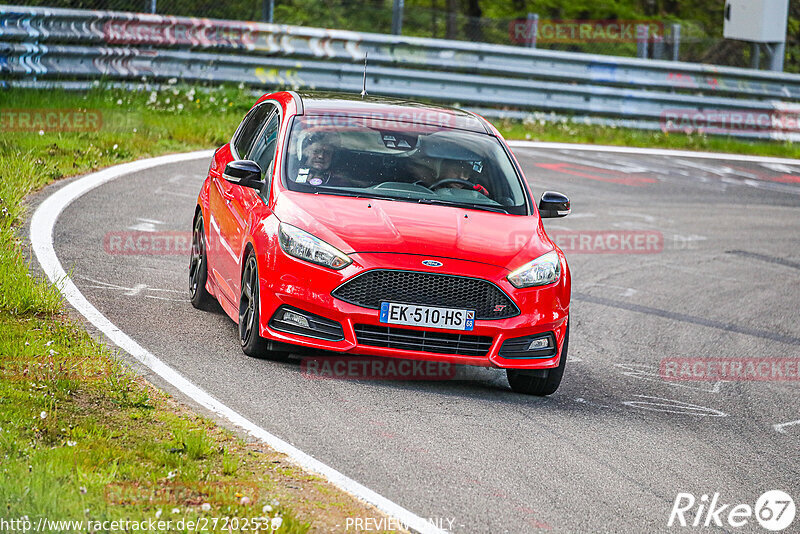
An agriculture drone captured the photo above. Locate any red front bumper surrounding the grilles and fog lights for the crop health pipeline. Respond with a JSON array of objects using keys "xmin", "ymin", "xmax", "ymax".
[{"xmin": 258, "ymin": 250, "xmax": 570, "ymax": 369}]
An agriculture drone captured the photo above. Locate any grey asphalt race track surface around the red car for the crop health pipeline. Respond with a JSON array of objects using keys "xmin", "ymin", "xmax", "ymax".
[{"xmin": 26, "ymin": 148, "xmax": 800, "ymax": 533}]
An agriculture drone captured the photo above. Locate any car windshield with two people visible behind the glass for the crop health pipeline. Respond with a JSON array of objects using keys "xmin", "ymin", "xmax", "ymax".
[{"xmin": 286, "ymin": 115, "xmax": 527, "ymax": 215}]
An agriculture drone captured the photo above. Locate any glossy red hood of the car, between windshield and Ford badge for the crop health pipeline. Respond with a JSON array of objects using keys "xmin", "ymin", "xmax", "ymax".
[{"xmin": 275, "ymin": 191, "xmax": 553, "ymax": 269}]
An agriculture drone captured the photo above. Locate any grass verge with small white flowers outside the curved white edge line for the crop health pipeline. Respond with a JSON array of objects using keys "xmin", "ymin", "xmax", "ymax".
[{"xmin": 0, "ymin": 87, "xmax": 396, "ymax": 533}]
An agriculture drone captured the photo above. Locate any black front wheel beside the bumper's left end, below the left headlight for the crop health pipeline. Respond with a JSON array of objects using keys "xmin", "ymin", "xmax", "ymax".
[{"xmin": 239, "ymin": 252, "xmax": 289, "ymax": 361}]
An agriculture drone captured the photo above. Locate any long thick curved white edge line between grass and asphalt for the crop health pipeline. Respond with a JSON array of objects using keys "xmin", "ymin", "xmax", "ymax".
[{"xmin": 31, "ymin": 150, "xmax": 444, "ymax": 534}]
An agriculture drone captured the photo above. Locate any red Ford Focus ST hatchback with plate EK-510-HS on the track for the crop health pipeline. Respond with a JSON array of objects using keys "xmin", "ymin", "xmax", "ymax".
[{"xmin": 189, "ymin": 92, "xmax": 570, "ymax": 395}]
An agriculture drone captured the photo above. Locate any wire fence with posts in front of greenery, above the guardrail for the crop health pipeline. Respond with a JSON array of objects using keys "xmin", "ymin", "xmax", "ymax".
[{"xmin": 7, "ymin": 0, "xmax": 800, "ymax": 72}]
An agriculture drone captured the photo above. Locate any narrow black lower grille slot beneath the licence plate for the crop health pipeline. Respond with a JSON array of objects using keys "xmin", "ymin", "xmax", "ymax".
[{"xmin": 354, "ymin": 324, "xmax": 492, "ymax": 356}]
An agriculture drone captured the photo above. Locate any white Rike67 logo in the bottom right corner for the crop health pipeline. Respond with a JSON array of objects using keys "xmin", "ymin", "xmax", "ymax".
[{"xmin": 667, "ymin": 490, "xmax": 796, "ymax": 532}]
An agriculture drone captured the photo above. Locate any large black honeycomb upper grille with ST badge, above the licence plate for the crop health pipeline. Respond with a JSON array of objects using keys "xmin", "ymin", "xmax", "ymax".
[{"xmin": 332, "ymin": 269, "xmax": 519, "ymax": 319}]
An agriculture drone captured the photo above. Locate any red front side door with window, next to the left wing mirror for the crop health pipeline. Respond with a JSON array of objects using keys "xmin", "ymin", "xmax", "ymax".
[{"xmin": 208, "ymin": 103, "xmax": 274, "ymax": 305}]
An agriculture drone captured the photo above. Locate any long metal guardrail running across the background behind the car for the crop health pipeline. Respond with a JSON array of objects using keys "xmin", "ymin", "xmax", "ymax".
[{"xmin": 0, "ymin": 6, "xmax": 800, "ymax": 139}]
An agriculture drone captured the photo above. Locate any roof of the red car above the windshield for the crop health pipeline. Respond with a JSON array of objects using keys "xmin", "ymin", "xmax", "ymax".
[{"xmin": 299, "ymin": 92, "xmax": 491, "ymax": 134}]
